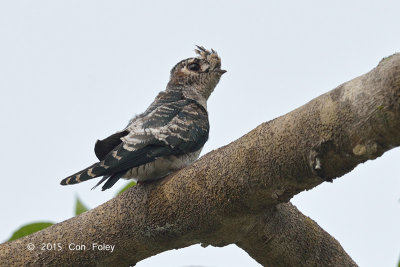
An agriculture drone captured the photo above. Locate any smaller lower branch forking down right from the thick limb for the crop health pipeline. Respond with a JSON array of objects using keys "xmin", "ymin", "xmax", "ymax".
[{"xmin": 236, "ymin": 203, "xmax": 357, "ymax": 267}]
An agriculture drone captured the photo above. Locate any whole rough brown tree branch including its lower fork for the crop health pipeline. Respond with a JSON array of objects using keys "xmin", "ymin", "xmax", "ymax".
[{"xmin": 0, "ymin": 54, "xmax": 400, "ymax": 266}]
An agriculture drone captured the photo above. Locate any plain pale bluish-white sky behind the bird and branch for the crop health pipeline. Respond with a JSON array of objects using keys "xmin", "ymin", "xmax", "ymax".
[{"xmin": 0, "ymin": 0, "xmax": 400, "ymax": 267}]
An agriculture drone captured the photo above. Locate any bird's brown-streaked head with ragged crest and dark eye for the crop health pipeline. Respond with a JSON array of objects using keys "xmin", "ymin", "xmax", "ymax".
[{"xmin": 168, "ymin": 46, "xmax": 226, "ymax": 99}]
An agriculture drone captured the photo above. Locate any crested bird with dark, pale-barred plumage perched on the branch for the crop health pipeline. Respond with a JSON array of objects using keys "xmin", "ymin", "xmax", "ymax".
[{"xmin": 61, "ymin": 46, "xmax": 226, "ymax": 191}]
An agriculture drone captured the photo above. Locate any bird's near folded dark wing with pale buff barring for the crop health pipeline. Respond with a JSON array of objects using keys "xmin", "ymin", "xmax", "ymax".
[{"xmin": 97, "ymin": 100, "xmax": 209, "ymax": 174}]
